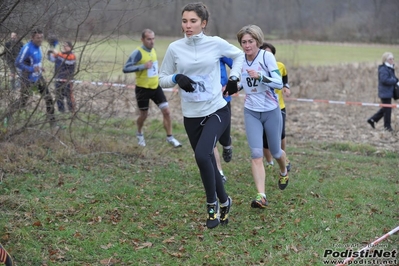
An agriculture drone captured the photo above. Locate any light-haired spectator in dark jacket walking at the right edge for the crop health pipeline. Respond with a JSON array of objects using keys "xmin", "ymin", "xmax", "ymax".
[{"xmin": 367, "ymin": 52, "xmax": 399, "ymax": 132}]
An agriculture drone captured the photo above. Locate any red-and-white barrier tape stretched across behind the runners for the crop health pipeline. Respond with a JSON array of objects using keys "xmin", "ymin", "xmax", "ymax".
[{"xmin": 54, "ymin": 79, "xmax": 399, "ymax": 108}]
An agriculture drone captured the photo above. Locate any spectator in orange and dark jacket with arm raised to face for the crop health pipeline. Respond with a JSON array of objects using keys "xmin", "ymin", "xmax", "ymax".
[{"xmin": 47, "ymin": 41, "xmax": 76, "ymax": 113}]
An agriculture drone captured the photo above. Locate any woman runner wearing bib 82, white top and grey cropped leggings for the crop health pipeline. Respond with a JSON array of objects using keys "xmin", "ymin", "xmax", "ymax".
[{"xmin": 225, "ymin": 25, "xmax": 289, "ymax": 209}]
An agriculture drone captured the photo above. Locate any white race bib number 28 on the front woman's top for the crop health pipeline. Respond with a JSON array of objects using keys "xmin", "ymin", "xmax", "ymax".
[{"xmin": 181, "ymin": 75, "xmax": 213, "ymax": 102}]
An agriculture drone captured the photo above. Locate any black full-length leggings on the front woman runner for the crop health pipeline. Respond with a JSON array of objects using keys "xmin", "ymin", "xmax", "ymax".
[{"xmin": 184, "ymin": 105, "xmax": 231, "ymax": 203}]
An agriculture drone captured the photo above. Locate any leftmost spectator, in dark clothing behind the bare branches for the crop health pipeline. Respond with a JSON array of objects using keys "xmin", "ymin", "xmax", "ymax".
[{"xmin": 5, "ymin": 32, "xmax": 24, "ymax": 90}]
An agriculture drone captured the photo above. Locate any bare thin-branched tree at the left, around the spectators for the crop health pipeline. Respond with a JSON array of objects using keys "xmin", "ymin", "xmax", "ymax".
[{"xmin": 0, "ymin": 0, "xmax": 173, "ymax": 140}]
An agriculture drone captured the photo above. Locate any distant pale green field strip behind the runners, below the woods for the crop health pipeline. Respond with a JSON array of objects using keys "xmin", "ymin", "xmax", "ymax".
[{"xmin": 43, "ymin": 37, "xmax": 399, "ymax": 82}]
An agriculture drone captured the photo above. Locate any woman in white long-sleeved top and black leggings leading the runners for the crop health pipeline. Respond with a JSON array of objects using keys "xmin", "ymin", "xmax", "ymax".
[{"xmin": 159, "ymin": 2, "xmax": 244, "ymax": 228}]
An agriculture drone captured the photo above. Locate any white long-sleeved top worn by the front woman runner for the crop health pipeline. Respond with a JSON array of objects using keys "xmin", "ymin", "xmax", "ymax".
[{"xmin": 159, "ymin": 33, "xmax": 244, "ymax": 118}]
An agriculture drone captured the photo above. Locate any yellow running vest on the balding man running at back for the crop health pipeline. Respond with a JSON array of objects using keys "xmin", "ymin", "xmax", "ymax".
[{"xmin": 136, "ymin": 47, "xmax": 159, "ymax": 89}]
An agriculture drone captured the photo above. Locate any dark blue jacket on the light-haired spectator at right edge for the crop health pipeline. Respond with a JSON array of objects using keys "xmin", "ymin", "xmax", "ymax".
[{"xmin": 378, "ymin": 64, "xmax": 398, "ymax": 99}]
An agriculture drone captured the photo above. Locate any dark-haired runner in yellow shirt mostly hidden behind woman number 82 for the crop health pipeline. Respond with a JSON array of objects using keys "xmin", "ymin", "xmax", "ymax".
[{"xmin": 260, "ymin": 42, "xmax": 291, "ymax": 171}]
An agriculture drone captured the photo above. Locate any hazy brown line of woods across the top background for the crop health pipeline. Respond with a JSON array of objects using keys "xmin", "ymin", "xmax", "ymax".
[{"xmin": 0, "ymin": 0, "xmax": 399, "ymax": 43}]
